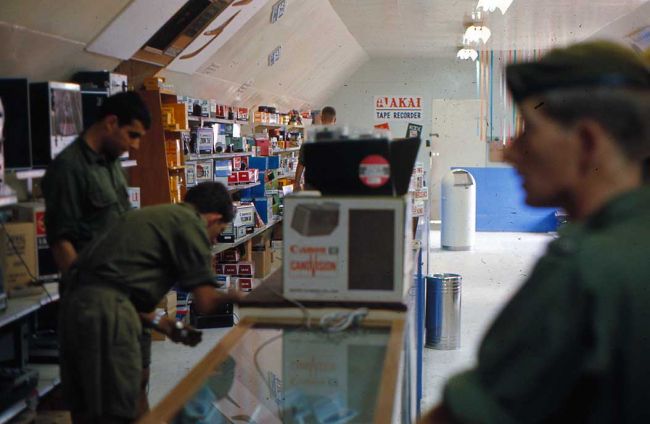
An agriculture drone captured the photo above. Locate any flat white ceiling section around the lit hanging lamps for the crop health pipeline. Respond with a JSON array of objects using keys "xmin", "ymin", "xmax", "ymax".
[{"xmin": 330, "ymin": 0, "xmax": 650, "ymax": 57}]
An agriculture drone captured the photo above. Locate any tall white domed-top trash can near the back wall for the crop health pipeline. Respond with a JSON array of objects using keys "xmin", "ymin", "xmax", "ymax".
[{"xmin": 440, "ymin": 169, "xmax": 476, "ymax": 250}]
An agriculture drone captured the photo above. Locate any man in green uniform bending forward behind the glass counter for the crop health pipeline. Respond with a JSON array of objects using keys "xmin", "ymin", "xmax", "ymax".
[{"xmin": 59, "ymin": 183, "xmax": 237, "ymax": 424}]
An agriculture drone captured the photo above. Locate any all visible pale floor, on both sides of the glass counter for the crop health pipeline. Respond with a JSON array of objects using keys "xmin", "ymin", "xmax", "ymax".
[{"xmin": 149, "ymin": 232, "xmax": 551, "ymax": 416}]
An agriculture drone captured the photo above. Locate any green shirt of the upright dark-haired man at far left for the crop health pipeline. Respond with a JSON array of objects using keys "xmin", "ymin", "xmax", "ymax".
[{"xmin": 43, "ymin": 137, "xmax": 131, "ymax": 252}]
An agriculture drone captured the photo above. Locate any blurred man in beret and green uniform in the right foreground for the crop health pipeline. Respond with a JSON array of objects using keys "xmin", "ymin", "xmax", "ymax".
[{"xmin": 423, "ymin": 42, "xmax": 650, "ymax": 424}]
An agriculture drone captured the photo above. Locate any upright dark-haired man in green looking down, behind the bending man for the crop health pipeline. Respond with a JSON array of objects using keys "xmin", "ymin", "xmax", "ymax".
[{"xmin": 43, "ymin": 92, "xmax": 151, "ymax": 418}]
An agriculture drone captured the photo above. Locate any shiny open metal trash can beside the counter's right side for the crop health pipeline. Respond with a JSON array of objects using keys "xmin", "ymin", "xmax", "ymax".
[{"xmin": 425, "ymin": 274, "xmax": 463, "ymax": 350}]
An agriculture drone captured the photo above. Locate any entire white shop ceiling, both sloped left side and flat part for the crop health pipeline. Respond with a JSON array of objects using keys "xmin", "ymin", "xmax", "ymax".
[{"xmin": 0, "ymin": 0, "xmax": 650, "ymax": 110}]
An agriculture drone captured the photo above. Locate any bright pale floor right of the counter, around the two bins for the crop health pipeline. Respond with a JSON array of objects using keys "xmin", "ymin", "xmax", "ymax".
[{"xmin": 422, "ymin": 232, "xmax": 552, "ymax": 410}]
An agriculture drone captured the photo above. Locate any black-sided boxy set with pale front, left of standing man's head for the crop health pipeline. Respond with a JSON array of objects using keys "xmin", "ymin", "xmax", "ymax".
[{"xmin": 29, "ymin": 81, "xmax": 83, "ymax": 166}]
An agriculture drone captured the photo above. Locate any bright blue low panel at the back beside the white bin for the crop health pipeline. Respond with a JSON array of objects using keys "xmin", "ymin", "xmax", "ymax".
[{"xmin": 456, "ymin": 168, "xmax": 557, "ymax": 233}]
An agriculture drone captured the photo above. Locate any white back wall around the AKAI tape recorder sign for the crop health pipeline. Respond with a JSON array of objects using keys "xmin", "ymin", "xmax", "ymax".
[{"xmin": 321, "ymin": 58, "xmax": 485, "ymax": 218}]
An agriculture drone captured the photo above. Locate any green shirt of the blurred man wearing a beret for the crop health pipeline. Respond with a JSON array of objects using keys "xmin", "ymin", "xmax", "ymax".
[{"xmin": 444, "ymin": 187, "xmax": 650, "ymax": 424}]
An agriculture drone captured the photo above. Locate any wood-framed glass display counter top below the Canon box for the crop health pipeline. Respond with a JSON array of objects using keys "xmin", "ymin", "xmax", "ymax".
[{"xmin": 140, "ymin": 318, "xmax": 405, "ymax": 424}]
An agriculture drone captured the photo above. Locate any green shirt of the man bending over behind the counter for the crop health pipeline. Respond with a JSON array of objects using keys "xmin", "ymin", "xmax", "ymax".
[{"xmin": 71, "ymin": 204, "xmax": 214, "ymax": 312}]
